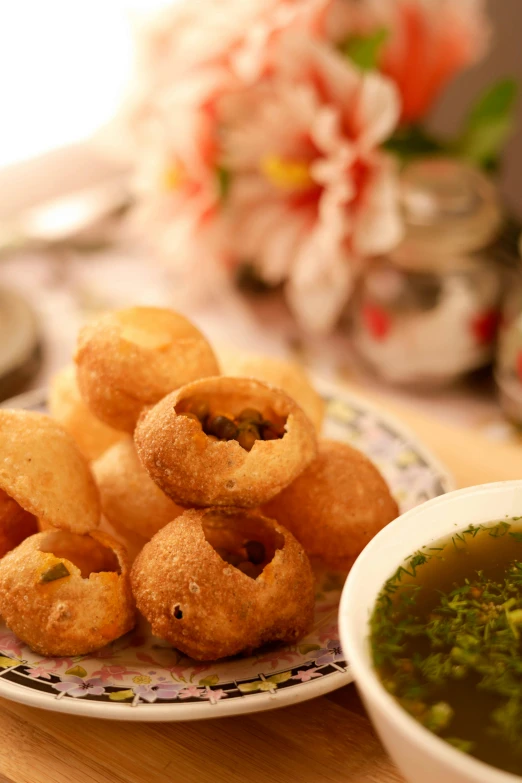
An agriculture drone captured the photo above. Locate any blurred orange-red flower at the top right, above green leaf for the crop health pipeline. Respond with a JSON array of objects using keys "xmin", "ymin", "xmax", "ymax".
[{"xmin": 329, "ymin": 0, "xmax": 489, "ymax": 123}]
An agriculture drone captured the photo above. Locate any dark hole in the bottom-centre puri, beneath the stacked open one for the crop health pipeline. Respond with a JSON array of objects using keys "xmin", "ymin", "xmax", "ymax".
[{"xmin": 202, "ymin": 512, "xmax": 284, "ymax": 579}]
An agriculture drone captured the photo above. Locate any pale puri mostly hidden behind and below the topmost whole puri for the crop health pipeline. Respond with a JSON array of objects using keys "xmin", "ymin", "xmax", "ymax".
[{"xmin": 49, "ymin": 364, "xmax": 124, "ymax": 461}]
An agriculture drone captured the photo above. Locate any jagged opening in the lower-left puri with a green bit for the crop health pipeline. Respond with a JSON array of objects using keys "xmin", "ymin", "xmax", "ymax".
[{"xmin": 40, "ymin": 530, "xmax": 121, "ymax": 579}]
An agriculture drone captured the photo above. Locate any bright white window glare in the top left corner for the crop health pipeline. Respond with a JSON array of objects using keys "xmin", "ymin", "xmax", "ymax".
[{"xmin": 0, "ymin": 0, "xmax": 171, "ymax": 166}]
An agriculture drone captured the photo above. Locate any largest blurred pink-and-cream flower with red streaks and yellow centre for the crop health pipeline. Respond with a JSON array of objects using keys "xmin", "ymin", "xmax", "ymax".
[{"xmin": 219, "ymin": 35, "xmax": 402, "ymax": 331}]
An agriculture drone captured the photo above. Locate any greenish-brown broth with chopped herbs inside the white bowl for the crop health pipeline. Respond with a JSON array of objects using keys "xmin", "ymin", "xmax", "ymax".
[{"xmin": 371, "ymin": 518, "xmax": 522, "ymax": 775}]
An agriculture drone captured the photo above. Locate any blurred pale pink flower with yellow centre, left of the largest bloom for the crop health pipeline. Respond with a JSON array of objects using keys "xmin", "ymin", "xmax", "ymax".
[{"xmin": 133, "ymin": 67, "xmax": 230, "ymax": 290}]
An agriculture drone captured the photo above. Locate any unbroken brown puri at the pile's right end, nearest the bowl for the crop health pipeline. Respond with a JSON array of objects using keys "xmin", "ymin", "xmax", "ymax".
[{"xmin": 263, "ymin": 440, "xmax": 399, "ymax": 570}]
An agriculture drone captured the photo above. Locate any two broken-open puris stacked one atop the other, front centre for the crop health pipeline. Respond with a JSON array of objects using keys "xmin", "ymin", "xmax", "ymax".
[{"xmin": 131, "ymin": 377, "xmax": 316, "ymax": 660}]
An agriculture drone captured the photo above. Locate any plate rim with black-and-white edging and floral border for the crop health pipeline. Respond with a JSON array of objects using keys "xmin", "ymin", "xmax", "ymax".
[{"xmin": 0, "ymin": 379, "xmax": 455, "ymax": 721}]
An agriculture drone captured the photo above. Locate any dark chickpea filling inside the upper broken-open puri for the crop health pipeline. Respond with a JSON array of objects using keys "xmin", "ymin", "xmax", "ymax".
[{"xmin": 176, "ymin": 397, "xmax": 286, "ymax": 451}]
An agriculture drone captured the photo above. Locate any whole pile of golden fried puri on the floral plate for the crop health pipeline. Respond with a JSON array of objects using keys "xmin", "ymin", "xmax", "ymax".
[{"xmin": 0, "ymin": 307, "xmax": 397, "ymax": 660}]
